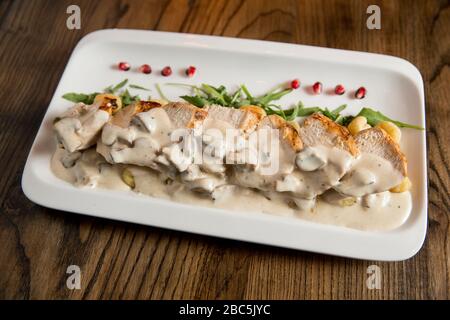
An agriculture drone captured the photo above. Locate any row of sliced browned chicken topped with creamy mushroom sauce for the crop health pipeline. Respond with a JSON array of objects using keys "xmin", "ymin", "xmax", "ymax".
[{"xmin": 55, "ymin": 97, "xmax": 406, "ymax": 207}]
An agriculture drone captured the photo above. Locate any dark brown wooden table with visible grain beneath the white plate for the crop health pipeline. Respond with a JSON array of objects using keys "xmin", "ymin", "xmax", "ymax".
[{"xmin": 0, "ymin": 0, "xmax": 450, "ymax": 299}]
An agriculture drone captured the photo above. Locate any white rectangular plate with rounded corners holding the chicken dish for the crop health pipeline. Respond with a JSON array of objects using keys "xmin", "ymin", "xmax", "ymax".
[{"xmin": 22, "ymin": 30, "xmax": 427, "ymax": 260}]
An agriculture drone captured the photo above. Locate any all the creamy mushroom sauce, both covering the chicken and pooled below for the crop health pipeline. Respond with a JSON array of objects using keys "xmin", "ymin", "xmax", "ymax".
[{"xmin": 51, "ymin": 104, "xmax": 411, "ymax": 231}]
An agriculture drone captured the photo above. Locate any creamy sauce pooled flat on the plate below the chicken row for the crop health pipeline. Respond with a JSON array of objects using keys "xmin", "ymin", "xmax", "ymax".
[{"xmin": 51, "ymin": 144, "xmax": 411, "ymax": 231}]
